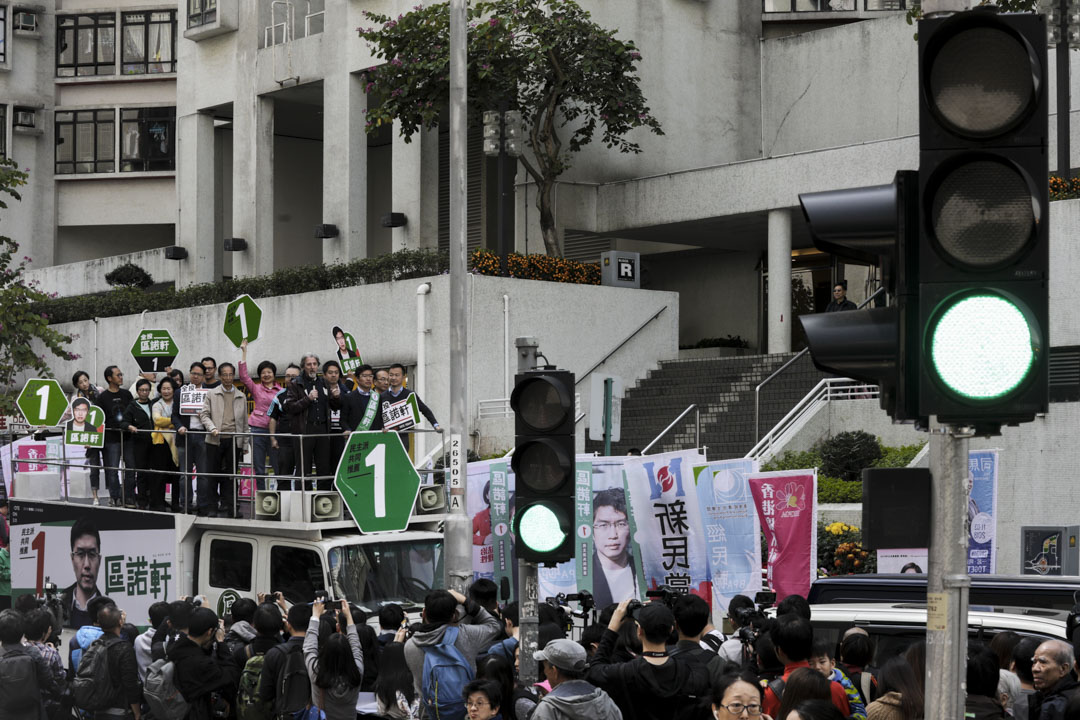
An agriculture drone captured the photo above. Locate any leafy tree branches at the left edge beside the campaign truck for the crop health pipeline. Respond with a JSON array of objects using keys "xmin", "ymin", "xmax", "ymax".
[{"xmin": 0, "ymin": 158, "xmax": 79, "ymax": 415}]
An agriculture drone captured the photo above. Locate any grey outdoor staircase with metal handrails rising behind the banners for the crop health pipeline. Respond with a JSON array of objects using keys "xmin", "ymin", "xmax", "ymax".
[{"xmin": 585, "ymin": 353, "xmax": 826, "ymax": 460}]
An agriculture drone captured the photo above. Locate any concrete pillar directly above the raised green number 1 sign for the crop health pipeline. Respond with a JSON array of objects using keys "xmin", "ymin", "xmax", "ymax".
[{"xmin": 232, "ymin": 95, "xmax": 274, "ymax": 277}]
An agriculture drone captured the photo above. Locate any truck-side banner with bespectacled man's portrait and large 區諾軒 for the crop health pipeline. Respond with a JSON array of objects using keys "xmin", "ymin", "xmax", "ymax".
[{"xmin": 10, "ymin": 499, "xmax": 179, "ymax": 628}]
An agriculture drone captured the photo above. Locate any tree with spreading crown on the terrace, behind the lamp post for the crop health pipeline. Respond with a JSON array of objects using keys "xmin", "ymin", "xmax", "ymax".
[{"xmin": 360, "ymin": 0, "xmax": 663, "ymax": 255}]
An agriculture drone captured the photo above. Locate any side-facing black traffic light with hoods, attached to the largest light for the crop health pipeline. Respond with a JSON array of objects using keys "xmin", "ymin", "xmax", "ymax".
[{"xmin": 799, "ymin": 171, "xmax": 919, "ymax": 420}]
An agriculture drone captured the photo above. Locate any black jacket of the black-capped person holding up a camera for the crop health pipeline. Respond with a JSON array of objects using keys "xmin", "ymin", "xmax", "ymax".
[{"xmin": 585, "ymin": 629, "xmax": 708, "ymax": 720}]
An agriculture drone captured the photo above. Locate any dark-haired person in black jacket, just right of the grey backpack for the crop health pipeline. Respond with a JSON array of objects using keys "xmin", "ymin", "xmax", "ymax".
[{"xmin": 167, "ymin": 608, "xmax": 239, "ymax": 720}]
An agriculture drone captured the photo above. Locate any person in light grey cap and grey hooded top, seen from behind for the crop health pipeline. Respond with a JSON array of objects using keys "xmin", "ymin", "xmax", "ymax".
[{"xmin": 530, "ymin": 639, "xmax": 622, "ymax": 720}]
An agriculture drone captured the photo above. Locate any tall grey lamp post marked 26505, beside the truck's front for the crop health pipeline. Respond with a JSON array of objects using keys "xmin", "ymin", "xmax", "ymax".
[{"xmin": 445, "ymin": 0, "xmax": 472, "ymax": 593}]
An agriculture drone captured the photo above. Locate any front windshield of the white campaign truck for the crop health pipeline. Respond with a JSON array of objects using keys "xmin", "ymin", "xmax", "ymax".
[{"xmin": 328, "ymin": 540, "xmax": 443, "ymax": 610}]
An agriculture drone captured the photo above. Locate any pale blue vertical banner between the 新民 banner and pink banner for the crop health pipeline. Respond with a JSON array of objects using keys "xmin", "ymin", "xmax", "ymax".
[{"xmin": 693, "ymin": 459, "xmax": 761, "ymax": 617}]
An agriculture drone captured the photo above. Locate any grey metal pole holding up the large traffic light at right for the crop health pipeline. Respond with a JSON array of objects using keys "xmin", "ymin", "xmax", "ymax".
[{"xmin": 924, "ymin": 416, "xmax": 971, "ymax": 718}]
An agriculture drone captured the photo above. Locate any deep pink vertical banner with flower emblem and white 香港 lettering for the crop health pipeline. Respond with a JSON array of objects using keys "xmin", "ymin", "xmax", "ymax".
[{"xmin": 750, "ymin": 470, "xmax": 818, "ymax": 601}]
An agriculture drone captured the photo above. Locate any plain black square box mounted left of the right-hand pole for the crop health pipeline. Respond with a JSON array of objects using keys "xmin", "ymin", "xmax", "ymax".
[{"xmin": 862, "ymin": 467, "xmax": 930, "ymax": 549}]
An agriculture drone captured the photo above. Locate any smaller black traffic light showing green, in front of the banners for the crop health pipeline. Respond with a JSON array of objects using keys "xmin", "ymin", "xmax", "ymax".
[{"xmin": 510, "ymin": 370, "xmax": 575, "ymax": 565}]
